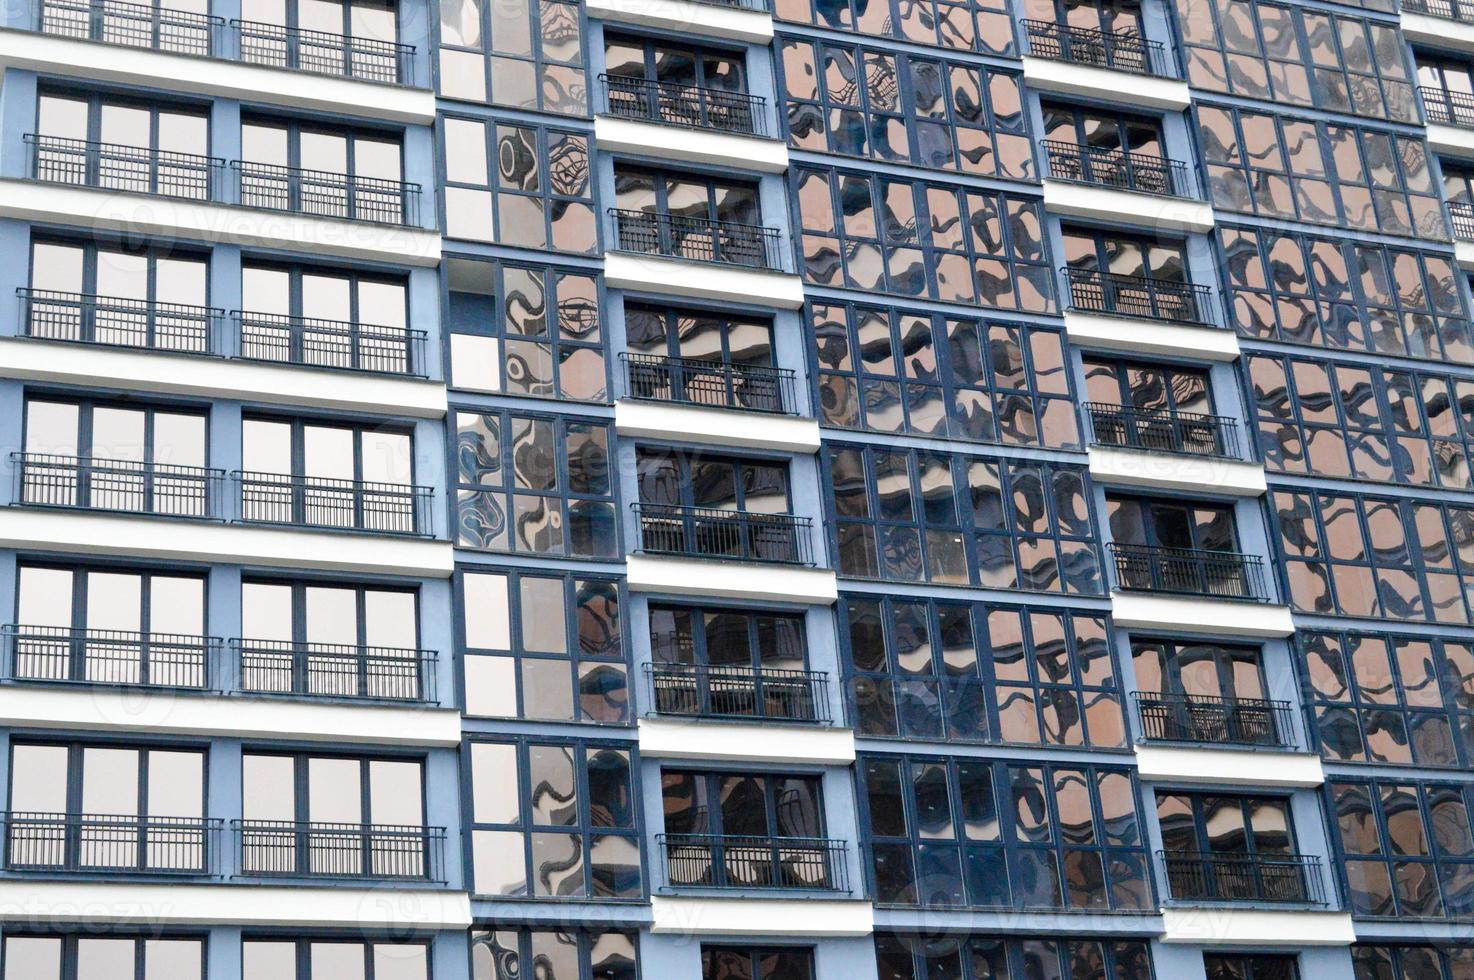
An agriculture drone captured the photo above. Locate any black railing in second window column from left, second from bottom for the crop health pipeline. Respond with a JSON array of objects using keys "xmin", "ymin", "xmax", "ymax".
[{"xmin": 230, "ymin": 640, "xmax": 435, "ymax": 703}]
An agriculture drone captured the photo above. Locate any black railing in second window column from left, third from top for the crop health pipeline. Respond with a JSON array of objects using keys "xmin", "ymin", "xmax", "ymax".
[{"xmin": 230, "ymin": 311, "xmax": 426, "ymax": 377}]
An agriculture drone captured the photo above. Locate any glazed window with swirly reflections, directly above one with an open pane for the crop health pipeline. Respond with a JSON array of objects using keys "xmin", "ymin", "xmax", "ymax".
[{"xmin": 442, "ymin": 119, "xmax": 598, "ymax": 252}]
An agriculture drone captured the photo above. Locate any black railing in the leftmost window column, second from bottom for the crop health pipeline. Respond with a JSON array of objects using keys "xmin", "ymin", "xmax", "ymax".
[{"xmin": 0, "ymin": 623, "xmax": 220, "ymax": 691}]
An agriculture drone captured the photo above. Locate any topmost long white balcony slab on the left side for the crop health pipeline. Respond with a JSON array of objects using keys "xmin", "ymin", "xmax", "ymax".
[{"xmin": 0, "ymin": 28, "xmax": 435, "ymax": 125}]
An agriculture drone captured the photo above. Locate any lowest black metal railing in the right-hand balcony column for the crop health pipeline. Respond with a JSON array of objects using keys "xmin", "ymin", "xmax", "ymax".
[{"xmin": 1157, "ymin": 850, "xmax": 1327, "ymax": 905}]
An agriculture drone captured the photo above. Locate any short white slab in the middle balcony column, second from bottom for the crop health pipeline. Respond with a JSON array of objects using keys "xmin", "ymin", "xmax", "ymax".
[{"xmin": 640, "ymin": 718, "xmax": 855, "ymax": 766}]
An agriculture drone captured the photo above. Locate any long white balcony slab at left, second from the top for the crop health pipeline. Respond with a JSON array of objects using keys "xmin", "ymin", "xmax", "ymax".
[{"xmin": 0, "ymin": 180, "xmax": 441, "ymax": 267}]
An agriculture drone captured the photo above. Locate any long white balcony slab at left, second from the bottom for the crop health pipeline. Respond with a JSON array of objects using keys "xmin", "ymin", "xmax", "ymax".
[{"xmin": 0, "ymin": 682, "xmax": 460, "ymax": 746}]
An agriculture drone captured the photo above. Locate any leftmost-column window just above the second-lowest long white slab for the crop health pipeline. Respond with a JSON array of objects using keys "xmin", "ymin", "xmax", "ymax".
[{"xmin": 12, "ymin": 564, "xmax": 212, "ymax": 688}]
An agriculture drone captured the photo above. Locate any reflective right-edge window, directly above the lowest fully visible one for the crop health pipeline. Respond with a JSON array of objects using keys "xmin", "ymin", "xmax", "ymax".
[{"xmin": 1296, "ymin": 631, "xmax": 1474, "ymax": 768}]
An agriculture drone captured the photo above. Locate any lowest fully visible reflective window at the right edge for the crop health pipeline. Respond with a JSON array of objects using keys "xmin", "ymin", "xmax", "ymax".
[{"xmin": 1327, "ymin": 780, "xmax": 1474, "ymax": 920}]
